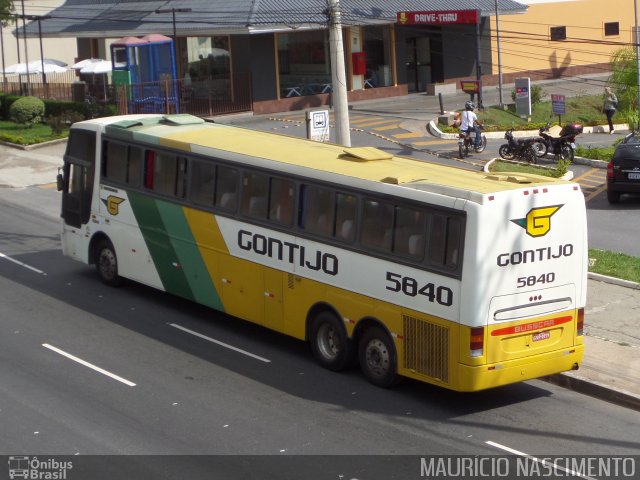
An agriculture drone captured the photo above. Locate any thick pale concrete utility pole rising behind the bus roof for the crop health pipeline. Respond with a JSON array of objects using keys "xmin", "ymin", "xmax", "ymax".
[{"xmin": 327, "ymin": 0, "xmax": 351, "ymax": 147}]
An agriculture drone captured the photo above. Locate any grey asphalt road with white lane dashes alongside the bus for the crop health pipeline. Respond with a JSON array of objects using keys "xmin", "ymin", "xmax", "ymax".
[{"xmin": 0, "ymin": 188, "xmax": 640, "ymax": 479}]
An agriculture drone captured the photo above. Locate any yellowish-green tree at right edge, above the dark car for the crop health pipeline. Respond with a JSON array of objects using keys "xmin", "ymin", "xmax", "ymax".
[{"xmin": 609, "ymin": 47, "xmax": 638, "ymax": 129}]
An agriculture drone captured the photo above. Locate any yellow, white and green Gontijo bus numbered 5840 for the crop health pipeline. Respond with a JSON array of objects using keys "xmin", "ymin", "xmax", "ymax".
[{"xmin": 58, "ymin": 114, "xmax": 588, "ymax": 392}]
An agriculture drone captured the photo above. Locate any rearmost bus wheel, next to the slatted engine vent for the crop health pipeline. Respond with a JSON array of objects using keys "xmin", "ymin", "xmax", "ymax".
[{"xmin": 358, "ymin": 326, "xmax": 400, "ymax": 388}]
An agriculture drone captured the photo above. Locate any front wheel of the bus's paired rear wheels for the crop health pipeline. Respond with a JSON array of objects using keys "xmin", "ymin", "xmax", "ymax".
[{"xmin": 310, "ymin": 311, "xmax": 356, "ymax": 372}]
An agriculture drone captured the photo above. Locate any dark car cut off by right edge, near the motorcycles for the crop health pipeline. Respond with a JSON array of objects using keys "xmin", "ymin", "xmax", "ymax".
[{"xmin": 607, "ymin": 133, "xmax": 640, "ymax": 203}]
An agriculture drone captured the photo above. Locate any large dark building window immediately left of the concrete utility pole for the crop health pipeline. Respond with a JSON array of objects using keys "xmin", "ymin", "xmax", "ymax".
[{"xmin": 278, "ymin": 30, "xmax": 332, "ymax": 98}]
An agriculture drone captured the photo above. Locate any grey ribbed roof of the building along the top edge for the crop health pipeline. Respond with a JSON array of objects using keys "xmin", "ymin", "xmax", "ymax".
[{"xmin": 21, "ymin": 0, "xmax": 527, "ymax": 38}]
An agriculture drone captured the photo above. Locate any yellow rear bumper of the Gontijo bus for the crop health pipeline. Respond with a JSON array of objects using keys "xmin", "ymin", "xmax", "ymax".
[{"xmin": 455, "ymin": 345, "xmax": 584, "ymax": 392}]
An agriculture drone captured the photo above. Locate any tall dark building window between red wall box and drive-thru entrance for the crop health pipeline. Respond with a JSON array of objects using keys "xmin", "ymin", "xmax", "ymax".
[{"xmin": 363, "ymin": 26, "xmax": 393, "ymax": 88}]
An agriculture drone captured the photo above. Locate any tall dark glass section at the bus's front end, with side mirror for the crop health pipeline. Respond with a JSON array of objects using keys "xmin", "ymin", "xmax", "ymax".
[{"xmin": 58, "ymin": 130, "xmax": 96, "ymax": 228}]
